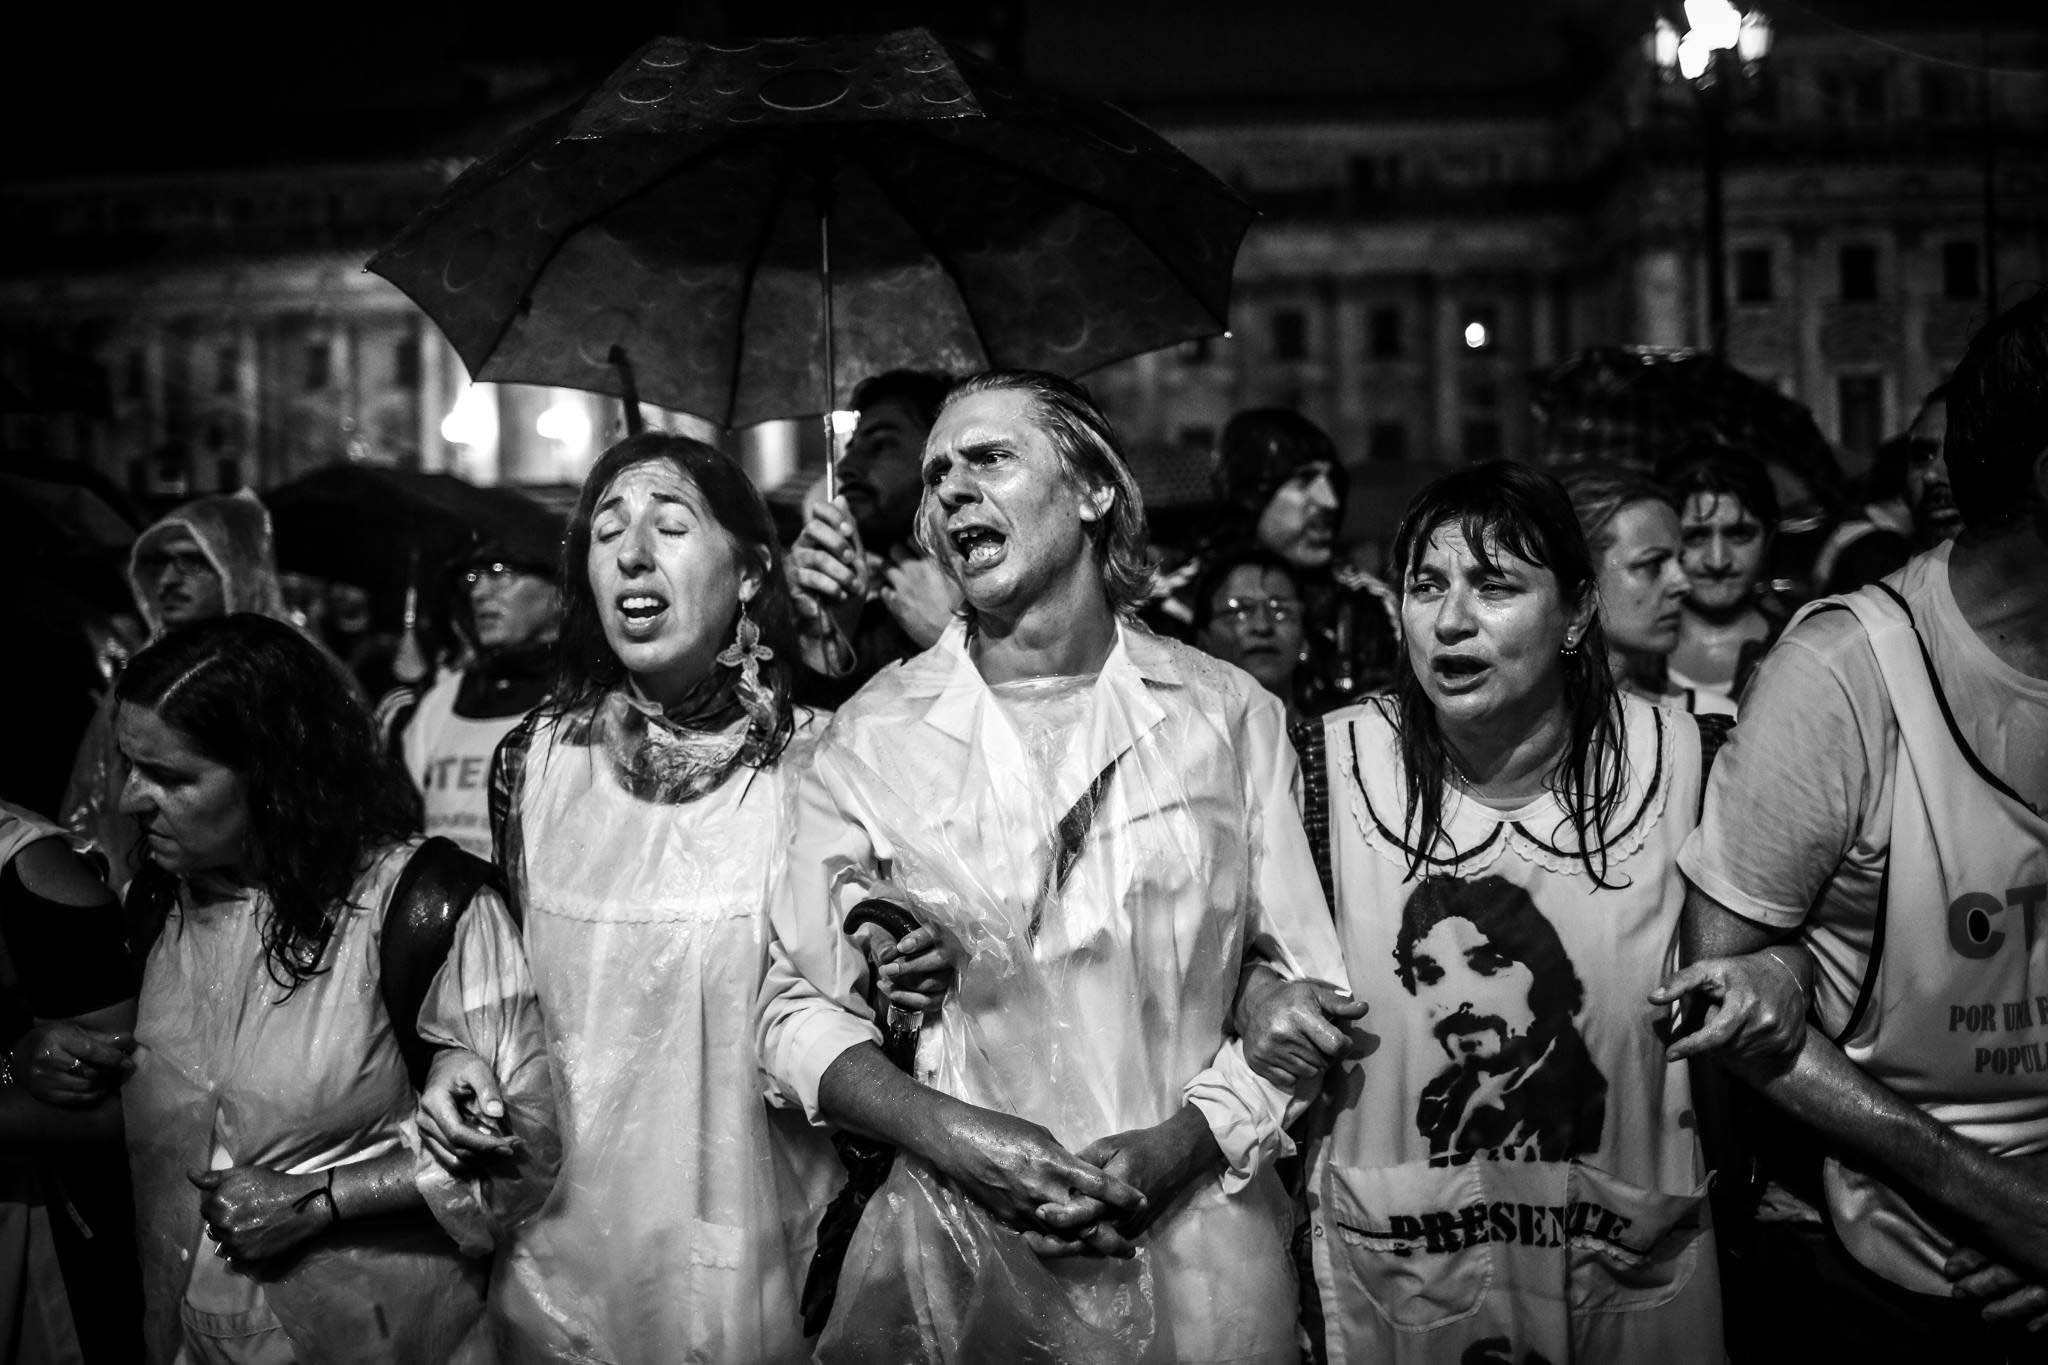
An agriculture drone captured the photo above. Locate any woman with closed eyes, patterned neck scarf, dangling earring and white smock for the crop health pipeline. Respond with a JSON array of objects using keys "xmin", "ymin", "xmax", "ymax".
[{"xmin": 432, "ymin": 432, "xmax": 842, "ymax": 1363}]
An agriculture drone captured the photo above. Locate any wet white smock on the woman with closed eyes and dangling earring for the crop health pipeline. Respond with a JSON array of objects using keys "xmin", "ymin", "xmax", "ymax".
[{"xmin": 492, "ymin": 706, "xmax": 844, "ymax": 1365}]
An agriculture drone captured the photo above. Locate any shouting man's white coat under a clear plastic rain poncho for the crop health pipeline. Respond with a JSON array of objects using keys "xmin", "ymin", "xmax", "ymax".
[{"xmin": 762, "ymin": 624, "xmax": 1343, "ymax": 1361}]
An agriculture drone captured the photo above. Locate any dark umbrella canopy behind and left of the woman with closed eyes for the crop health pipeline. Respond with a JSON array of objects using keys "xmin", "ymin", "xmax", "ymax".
[{"xmin": 264, "ymin": 465, "xmax": 563, "ymax": 602}]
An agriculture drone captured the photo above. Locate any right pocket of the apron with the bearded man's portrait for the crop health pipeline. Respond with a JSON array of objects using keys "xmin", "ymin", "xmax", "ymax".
[{"xmin": 1569, "ymin": 1162, "xmax": 1708, "ymax": 1316}]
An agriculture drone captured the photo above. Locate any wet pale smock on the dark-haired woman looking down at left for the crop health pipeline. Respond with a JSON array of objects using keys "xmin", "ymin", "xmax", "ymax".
[{"xmin": 121, "ymin": 841, "xmax": 555, "ymax": 1365}]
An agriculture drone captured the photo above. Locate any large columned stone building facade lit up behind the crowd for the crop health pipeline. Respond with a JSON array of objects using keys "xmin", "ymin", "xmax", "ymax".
[{"xmin": 0, "ymin": 10, "xmax": 2048, "ymax": 497}]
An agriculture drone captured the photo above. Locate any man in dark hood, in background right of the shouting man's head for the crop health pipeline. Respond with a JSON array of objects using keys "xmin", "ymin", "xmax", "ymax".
[{"xmin": 1147, "ymin": 407, "xmax": 1399, "ymax": 714}]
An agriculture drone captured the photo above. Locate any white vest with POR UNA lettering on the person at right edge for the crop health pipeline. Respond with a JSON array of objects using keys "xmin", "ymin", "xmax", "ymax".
[{"xmin": 1823, "ymin": 585, "xmax": 2048, "ymax": 1297}]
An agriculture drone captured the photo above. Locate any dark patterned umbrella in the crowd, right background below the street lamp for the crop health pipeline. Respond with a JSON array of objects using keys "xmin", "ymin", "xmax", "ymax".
[{"xmin": 1534, "ymin": 346, "xmax": 1841, "ymax": 505}]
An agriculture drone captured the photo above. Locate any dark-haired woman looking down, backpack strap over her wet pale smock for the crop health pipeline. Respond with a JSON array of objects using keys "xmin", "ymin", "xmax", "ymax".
[{"xmin": 115, "ymin": 614, "xmax": 553, "ymax": 1365}]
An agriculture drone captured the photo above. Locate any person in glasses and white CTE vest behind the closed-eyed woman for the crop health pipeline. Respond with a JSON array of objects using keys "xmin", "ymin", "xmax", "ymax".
[{"xmin": 377, "ymin": 540, "xmax": 561, "ymax": 857}]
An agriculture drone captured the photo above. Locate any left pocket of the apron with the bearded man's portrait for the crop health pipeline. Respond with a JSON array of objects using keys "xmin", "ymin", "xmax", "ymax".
[{"xmin": 1323, "ymin": 1160, "xmax": 1493, "ymax": 1332}]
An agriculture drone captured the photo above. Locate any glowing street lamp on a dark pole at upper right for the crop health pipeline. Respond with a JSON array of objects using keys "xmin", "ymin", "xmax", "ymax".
[{"xmin": 1649, "ymin": 0, "xmax": 1772, "ymax": 354}]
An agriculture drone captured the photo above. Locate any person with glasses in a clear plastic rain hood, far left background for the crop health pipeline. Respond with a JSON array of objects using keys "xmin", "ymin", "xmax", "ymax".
[{"xmin": 61, "ymin": 491, "xmax": 289, "ymax": 892}]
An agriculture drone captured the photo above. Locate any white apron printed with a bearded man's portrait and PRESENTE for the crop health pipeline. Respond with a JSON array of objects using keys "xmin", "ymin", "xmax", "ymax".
[{"xmin": 1309, "ymin": 698, "xmax": 1722, "ymax": 1365}]
